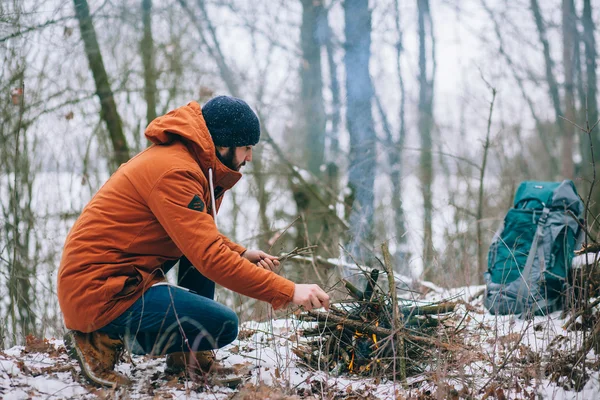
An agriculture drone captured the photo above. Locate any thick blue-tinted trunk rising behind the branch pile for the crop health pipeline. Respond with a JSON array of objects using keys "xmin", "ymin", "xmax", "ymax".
[{"xmin": 344, "ymin": 0, "xmax": 376, "ymax": 262}]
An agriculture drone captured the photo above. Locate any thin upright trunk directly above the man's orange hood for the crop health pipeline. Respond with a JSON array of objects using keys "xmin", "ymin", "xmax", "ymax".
[{"xmin": 140, "ymin": 0, "xmax": 156, "ymax": 128}]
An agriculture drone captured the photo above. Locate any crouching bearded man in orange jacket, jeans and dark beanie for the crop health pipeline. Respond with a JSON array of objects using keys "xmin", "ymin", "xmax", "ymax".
[{"xmin": 58, "ymin": 96, "xmax": 329, "ymax": 386}]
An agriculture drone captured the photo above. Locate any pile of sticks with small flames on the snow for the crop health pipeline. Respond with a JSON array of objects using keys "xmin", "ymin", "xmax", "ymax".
[{"xmin": 293, "ymin": 244, "xmax": 459, "ymax": 380}]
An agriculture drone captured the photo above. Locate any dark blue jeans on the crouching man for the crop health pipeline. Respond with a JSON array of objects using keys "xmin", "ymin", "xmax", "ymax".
[{"xmin": 99, "ymin": 258, "xmax": 238, "ymax": 355}]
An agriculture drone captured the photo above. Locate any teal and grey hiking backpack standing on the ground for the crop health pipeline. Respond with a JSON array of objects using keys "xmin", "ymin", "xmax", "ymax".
[{"xmin": 484, "ymin": 180, "xmax": 584, "ymax": 315}]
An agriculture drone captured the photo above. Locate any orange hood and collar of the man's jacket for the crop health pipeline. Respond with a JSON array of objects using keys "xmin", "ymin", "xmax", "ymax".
[{"xmin": 145, "ymin": 101, "xmax": 242, "ymax": 191}]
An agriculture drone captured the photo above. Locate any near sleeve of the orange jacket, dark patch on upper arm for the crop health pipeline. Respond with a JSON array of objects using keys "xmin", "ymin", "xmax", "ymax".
[{"xmin": 147, "ymin": 169, "xmax": 295, "ymax": 309}]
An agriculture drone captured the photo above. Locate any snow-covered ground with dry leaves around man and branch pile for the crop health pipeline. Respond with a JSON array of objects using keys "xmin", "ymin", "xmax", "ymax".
[{"xmin": 0, "ymin": 285, "xmax": 600, "ymax": 399}]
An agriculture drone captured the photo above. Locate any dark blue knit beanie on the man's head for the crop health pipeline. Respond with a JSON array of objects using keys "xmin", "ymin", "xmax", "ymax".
[{"xmin": 202, "ymin": 96, "xmax": 260, "ymax": 147}]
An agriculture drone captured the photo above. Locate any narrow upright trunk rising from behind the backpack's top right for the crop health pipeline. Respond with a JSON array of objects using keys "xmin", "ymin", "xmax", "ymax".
[{"xmin": 561, "ymin": 0, "xmax": 577, "ymax": 179}]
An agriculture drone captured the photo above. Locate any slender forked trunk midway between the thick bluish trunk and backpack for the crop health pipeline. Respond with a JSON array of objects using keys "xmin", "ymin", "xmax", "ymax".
[{"xmin": 417, "ymin": 0, "xmax": 436, "ymax": 280}]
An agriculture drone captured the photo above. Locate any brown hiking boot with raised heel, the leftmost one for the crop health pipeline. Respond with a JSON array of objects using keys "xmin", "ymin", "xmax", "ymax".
[{"xmin": 65, "ymin": 331, "xmax": 131, "ymax": 388}]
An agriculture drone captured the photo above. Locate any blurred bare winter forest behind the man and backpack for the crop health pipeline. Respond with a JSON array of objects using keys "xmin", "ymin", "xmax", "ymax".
[{"xmin": 0, "ymin": 0, "xmax": 600, "ymax": 348}]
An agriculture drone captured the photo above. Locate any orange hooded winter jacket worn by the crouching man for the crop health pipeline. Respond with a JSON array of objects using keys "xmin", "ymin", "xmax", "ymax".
[{"xmin": 58, "ymin": 102, "xmax": 294, "ymax": 332}]
